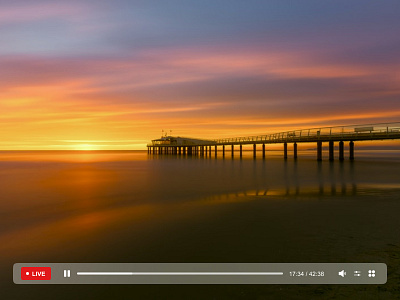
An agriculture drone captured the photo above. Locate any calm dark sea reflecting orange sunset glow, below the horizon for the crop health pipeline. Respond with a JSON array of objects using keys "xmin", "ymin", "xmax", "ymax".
[{"xmin": 0, "ymin": 150, "xmax": 400, "ymax": 299}]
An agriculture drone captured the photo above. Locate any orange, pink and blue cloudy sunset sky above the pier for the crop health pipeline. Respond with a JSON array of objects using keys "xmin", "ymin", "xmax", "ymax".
[{"xmin": 0, "ymin": 0, "xmax": 400, "ymax": 150}]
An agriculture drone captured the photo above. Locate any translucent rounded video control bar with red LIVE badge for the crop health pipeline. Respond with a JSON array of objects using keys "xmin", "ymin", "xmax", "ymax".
[{"xmin": 13, "ymin": 263, "xmax": 387, "ymax": 284}]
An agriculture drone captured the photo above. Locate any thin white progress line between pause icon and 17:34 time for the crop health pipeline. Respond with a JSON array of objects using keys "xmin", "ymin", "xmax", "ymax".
[{"xmin": 76, "ymin": 272, "xmax": 283, "ymax": 276}]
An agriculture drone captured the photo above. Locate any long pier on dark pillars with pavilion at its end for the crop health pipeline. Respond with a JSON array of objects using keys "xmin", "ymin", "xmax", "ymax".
[{"xmin": 147, "ymin": 122, "xmax": 400, "ymax": 161}]
